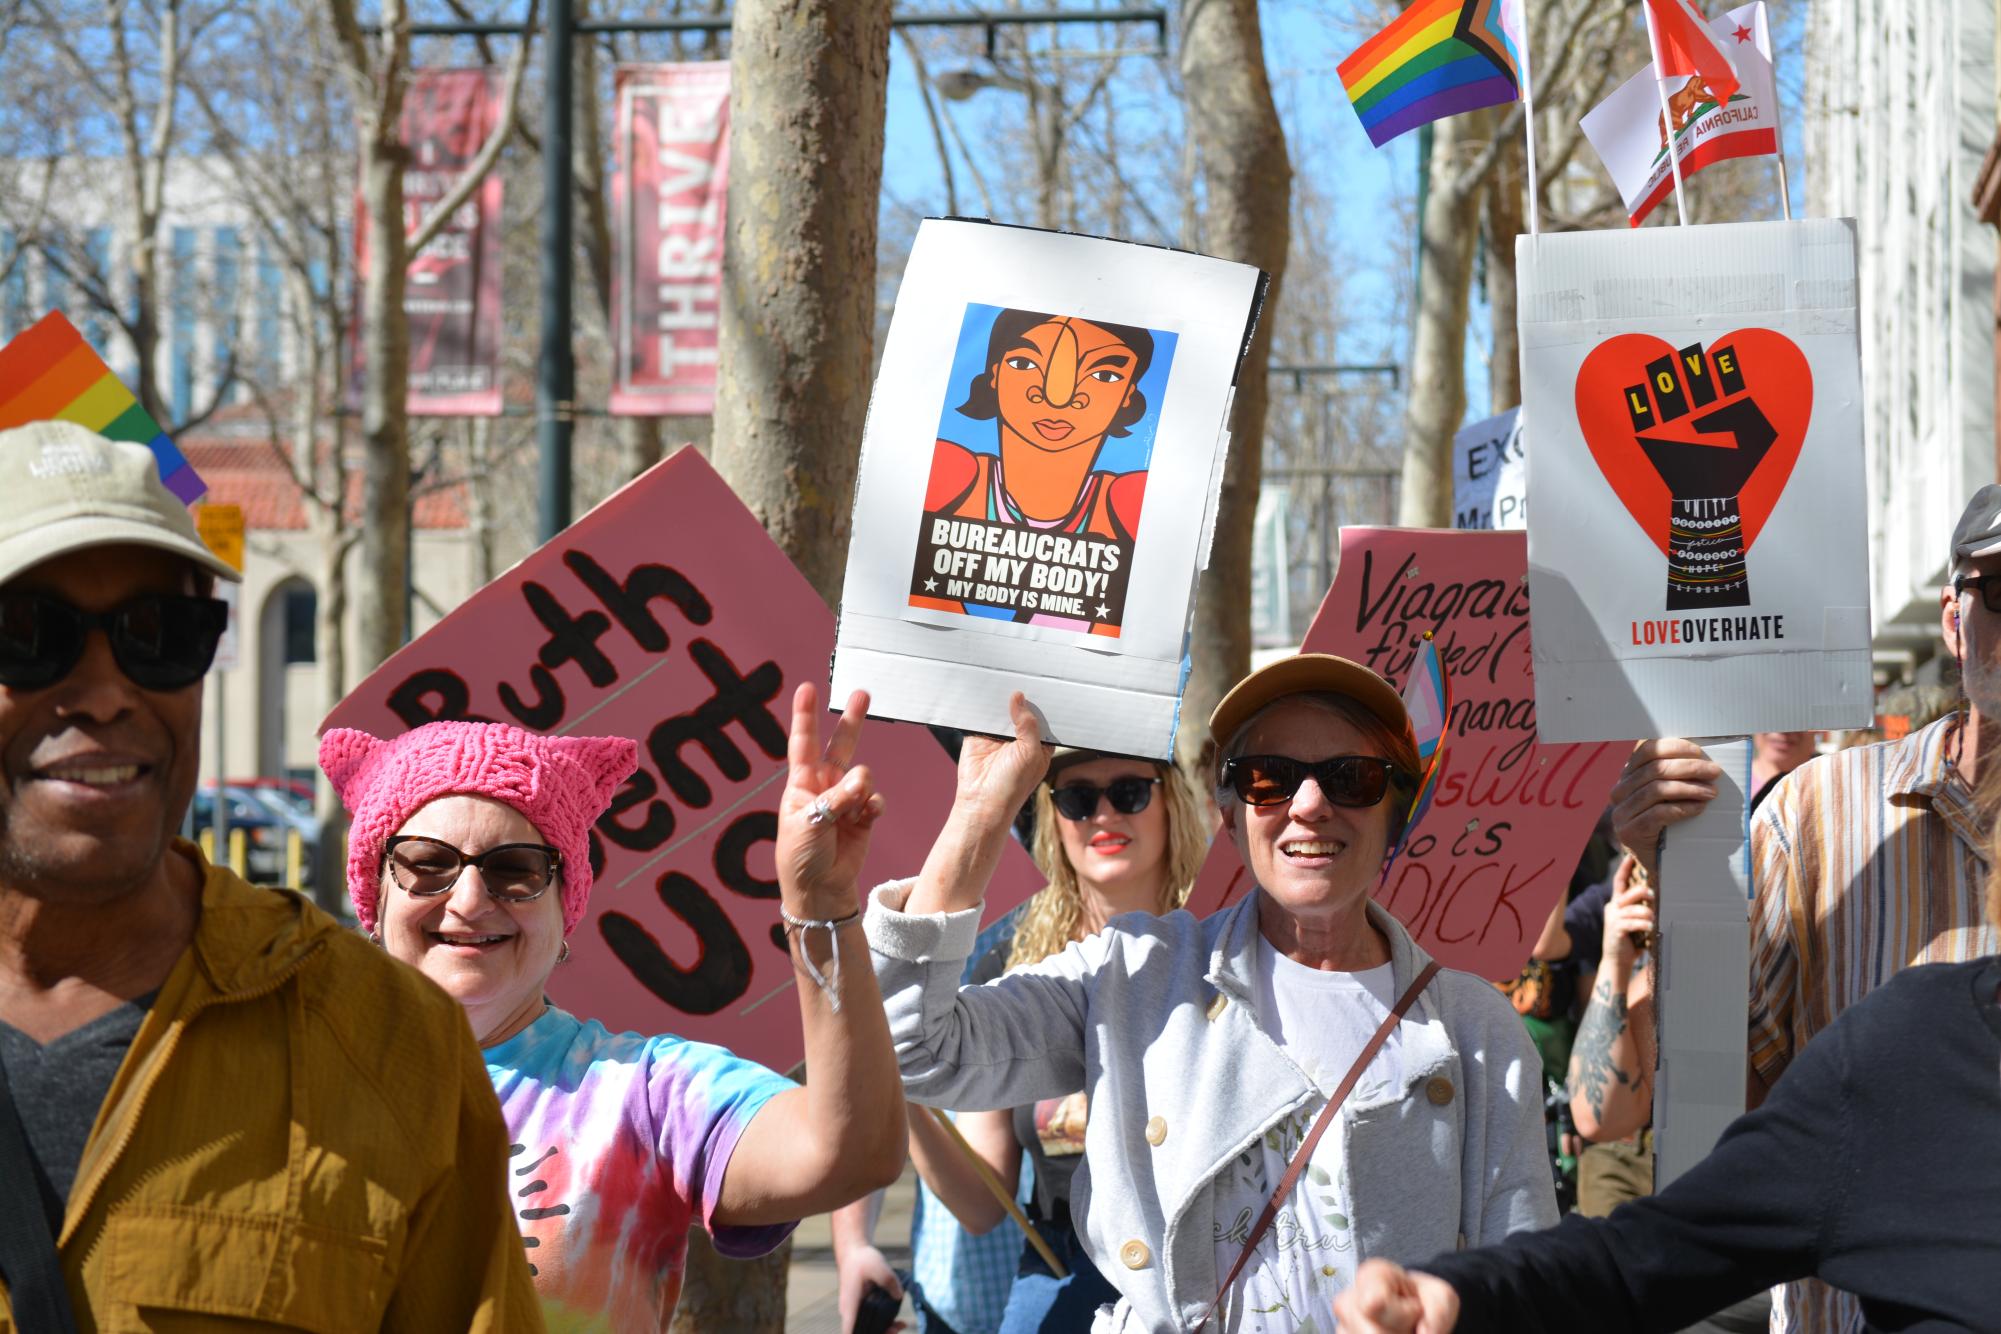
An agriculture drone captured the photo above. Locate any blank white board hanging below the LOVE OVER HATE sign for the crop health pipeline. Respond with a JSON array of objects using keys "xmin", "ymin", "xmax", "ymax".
[{"xmin": 1653, "ymin": 738, "xmax": 1751, "ymax": 1190}]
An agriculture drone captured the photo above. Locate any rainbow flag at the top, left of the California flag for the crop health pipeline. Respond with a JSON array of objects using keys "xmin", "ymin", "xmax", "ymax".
[{"xmin": 1341, "ymin": 0, "xmax": 1527, "ymax": 148}]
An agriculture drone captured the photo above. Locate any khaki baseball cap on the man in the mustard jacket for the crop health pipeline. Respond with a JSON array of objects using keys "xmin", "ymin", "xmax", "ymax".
[{"xmin": 0, "ymin": 422, "xmax": 242, "ymax": 584}]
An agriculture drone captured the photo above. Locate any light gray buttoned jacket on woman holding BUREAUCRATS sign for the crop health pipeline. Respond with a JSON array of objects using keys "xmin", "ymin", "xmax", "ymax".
[{"xmin": 866, "ymin": 882, "xmax": 1557, "ymax": 1334}]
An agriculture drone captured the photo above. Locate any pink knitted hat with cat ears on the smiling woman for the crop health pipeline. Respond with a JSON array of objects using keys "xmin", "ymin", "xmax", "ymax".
[{"xmin": 320, "ymin": 722, "xmax": 638, "ymax": 936}]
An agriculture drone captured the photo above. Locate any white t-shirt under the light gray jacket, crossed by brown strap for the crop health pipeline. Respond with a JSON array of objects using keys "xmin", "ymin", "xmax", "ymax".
[{"xmin": 1215, "ymin": 936, "xmax": 1403, "ymax": 1334}]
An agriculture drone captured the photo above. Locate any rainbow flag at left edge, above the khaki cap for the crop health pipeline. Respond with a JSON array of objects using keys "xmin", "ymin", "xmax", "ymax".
[{"xmin": 0, "ymin": 310, "xmax": 208, "ymax": 504}]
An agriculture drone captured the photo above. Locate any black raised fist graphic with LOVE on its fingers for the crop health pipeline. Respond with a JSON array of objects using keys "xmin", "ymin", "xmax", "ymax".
[{"xmin": 1625, "ymin": 344, "xmax": 1779, "ymax": 612}]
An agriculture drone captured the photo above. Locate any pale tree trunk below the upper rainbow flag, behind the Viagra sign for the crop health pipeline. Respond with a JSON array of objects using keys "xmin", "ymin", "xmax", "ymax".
[{"xmin": 1397, "ymin": 116, "xmax": 1479, "ymax": 528}]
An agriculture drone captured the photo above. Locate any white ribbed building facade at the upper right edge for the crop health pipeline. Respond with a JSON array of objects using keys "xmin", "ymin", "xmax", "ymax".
[{"xmin": 1803, "ymin": 0, "xmax": 1997, "ymax": 680}]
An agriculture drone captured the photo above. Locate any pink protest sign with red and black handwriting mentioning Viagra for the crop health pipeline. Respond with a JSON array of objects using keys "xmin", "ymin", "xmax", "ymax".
[{"xmin": 1189, "ymin": 528, "xmax": 1631, "ymax": 982}]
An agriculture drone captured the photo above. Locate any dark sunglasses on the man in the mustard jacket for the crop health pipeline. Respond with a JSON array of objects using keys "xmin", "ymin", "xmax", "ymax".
[{"xmin": 0, "ymin": 592, "xmax": 230, "ymax": 690}]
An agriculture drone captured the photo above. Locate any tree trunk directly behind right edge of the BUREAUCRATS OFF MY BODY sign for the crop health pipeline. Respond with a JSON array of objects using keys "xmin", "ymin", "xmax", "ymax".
[{"xmin": 1179, "ymin": 0, "xmax": 1293, "ymax": 762}]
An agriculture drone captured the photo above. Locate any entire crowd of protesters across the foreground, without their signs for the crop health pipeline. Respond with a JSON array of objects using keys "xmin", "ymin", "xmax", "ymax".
[{"xmin": 0, "ymin": 424, "xmax": 2001, "ymax": 1334}]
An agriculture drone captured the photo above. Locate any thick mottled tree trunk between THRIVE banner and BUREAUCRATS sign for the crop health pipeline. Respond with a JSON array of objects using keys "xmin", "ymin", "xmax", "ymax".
[{"xmin": 712, "ymin": 0, "xmax": 890, "ymax": 604}]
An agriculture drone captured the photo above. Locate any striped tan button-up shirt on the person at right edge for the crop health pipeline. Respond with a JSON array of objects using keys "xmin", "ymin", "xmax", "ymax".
[{"xmin": 1751, "ymin": 714, "xmax": 2001, "ymax": 1334}]
